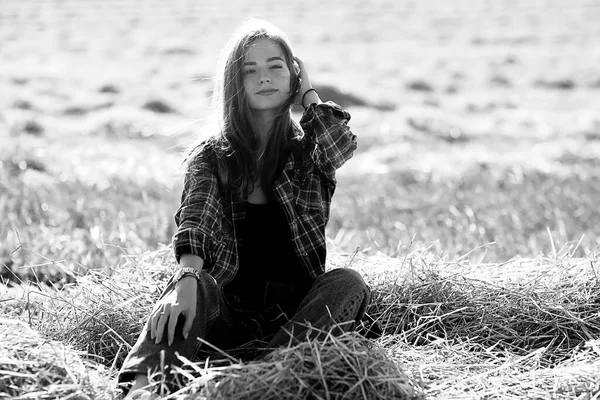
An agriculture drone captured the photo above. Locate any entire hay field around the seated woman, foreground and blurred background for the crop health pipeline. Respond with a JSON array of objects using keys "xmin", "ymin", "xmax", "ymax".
[{"xmin": 0, "ymin": 0, "xmax": 600, "ymax": 399}]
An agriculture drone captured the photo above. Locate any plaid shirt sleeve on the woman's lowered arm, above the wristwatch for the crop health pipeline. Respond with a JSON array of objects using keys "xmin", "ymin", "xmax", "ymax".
[{"xmin": 173, "ymin": 148, "xmax": 221, "ymax": 265}]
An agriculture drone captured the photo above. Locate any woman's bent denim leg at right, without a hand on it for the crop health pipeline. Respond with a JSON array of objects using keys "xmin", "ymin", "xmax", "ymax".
[{"xmin": 268, "ymin": 268, "xmax": 371, "ymax": 348}]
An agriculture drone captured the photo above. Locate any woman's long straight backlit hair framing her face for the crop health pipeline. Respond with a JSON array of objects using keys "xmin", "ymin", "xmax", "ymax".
[{"xmin": 186, "ymin": 19, "xmax": 300, "ymax": 198}]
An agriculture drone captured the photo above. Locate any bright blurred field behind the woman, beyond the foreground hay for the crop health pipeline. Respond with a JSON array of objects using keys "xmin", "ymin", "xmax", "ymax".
[{"xmin": 0, "ymin": 0, "xmax": 600, "ymax": 282}]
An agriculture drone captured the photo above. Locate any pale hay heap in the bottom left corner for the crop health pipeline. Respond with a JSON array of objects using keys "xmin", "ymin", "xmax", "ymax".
[{"xmin": 0, "ymin": 318, "xmax": 115, "ymax": 399}]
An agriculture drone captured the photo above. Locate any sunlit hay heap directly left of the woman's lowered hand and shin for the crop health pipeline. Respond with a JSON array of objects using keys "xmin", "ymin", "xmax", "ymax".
[{"xmin": 30, "ymin": 250, "xmax": 172, "ymax": 368}]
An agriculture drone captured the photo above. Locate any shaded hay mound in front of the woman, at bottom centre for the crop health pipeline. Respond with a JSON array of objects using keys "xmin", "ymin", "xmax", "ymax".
[{"xmin": 178, "ymin": 333, "xmax": 423, "ymax": 400}]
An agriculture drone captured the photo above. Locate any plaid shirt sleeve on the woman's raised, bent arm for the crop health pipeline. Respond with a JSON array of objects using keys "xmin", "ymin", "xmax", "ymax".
[{"xmin": 300, "ymin": 101, "xmax": 356, "ymax": 181}]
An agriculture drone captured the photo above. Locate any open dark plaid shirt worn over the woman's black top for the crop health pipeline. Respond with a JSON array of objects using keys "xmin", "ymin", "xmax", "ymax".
[{"xmin": 173, "ymin": 102, "xmax": 356, "ymax": 287}]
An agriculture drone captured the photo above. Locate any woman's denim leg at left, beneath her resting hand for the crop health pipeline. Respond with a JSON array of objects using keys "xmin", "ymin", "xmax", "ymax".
[{"xmin": 118, "ymin": 271, "xmax": 239, "ymax": 392}]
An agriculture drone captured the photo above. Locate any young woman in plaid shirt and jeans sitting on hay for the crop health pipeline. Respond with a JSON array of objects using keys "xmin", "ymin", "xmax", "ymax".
[{"xmin": 119, "ymin": 20, "xmax": 370, "ymax": 392}]
